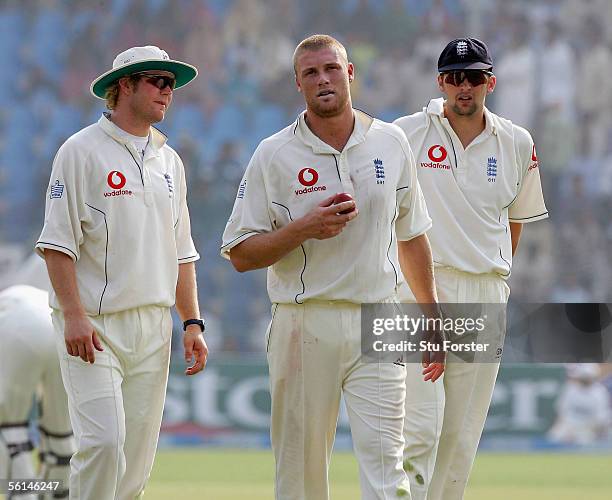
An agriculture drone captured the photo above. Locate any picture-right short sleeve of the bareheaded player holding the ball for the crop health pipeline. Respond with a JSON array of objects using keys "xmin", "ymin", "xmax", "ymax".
[{"xmin": 395, "ymin": 140, "xmax": 431, "ymax": 241}]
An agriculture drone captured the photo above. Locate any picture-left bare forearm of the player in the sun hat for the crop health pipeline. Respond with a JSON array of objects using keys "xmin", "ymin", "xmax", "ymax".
[{"xmin": 45, "ymin": 248, "xmax": 86, "ymax": 316}]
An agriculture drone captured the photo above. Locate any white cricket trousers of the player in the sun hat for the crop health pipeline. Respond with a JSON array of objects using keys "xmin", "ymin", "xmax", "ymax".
[{"xmin": 53, "ymin": 306, "xmax": 172, "ymax": 500}]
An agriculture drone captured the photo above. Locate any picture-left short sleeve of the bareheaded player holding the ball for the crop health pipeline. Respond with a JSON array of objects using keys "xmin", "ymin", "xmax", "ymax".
[{"xmin": 221, "ymin": 146, "xmax": 273, "ymax": 259}]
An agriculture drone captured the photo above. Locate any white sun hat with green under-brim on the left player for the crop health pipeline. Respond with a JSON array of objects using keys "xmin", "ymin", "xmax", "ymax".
[{"xmin": 90, "ymin": 45, "xmax": 198, "ymax": 99}]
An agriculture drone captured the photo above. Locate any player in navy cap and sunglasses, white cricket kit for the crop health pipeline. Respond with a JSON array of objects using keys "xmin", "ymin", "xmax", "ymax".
[{"xmin": 395, "ymin": 38, "xmax": 548, "ymax": 500}]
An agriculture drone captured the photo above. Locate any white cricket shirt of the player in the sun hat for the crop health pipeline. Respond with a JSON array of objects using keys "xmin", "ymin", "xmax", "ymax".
[{"xmin": 36, "ymin": 116, "xmax": 199, "ymax": 315}]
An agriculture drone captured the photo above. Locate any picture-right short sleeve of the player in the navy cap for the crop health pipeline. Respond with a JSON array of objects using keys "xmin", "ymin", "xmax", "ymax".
[{"xmin": 508, "ymin": 135, "xmax": 548, "ymax": 223}]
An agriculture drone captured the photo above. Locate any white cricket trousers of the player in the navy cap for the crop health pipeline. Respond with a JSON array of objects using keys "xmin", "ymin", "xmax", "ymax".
[{"xmin": 404, "ymin": 267, "xmax": 510, "ymax": 500}]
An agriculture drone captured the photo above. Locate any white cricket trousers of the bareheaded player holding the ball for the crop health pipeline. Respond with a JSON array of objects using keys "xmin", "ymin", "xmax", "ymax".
[{"xmin": 267, "ymin": 301, "xmax": 410, "ymax": 500}]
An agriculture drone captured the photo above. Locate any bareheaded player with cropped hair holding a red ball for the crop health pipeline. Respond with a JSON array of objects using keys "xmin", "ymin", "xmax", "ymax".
[{"xmin": 221, "ymin": 35, "xmax": 443, "ymax": 500}]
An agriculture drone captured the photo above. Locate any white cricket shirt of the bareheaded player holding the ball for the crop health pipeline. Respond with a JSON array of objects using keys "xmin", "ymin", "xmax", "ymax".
[{"xmin": 221, "ymin": 110, "xmax": 431, "ymax": 303}]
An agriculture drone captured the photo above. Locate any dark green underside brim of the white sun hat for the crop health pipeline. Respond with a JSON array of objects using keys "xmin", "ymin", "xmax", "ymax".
[{"xmin": 90, "ymin": 59, "xmax": 198, "ymax": 99}]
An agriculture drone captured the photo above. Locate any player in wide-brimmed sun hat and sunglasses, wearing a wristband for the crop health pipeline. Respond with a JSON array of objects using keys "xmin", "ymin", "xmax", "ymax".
[{"xmin": 36, "ymin": 46, "xmax": 208, "ymax": 500}]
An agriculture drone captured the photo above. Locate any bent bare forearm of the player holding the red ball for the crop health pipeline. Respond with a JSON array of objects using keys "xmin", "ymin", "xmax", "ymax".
[{"xmin": 230, "ymin": 221, "xmax": 305, "ymax": 272}]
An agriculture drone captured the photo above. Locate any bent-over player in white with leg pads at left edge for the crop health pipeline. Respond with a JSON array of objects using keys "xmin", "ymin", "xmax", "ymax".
[{"xmin": 0, "ymin": 256, "xmax": 75, "ymax": 500}]
